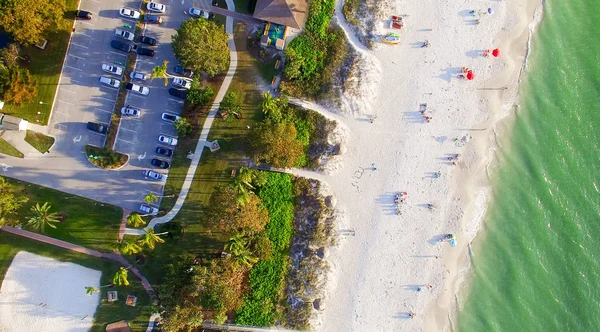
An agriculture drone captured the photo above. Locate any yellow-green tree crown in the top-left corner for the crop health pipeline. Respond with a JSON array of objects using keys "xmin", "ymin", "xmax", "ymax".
[{"xmin": 0, "ymin": 0, "xmax": 65, "ymax": 45}]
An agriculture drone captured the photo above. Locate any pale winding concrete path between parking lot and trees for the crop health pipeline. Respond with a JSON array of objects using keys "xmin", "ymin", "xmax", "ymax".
[{"xmin": 125, "ymin": 0, "xmax": 237, "ymax": 235}]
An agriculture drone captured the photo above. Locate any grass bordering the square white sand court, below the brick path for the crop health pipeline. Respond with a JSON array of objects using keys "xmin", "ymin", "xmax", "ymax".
[{"xmin": 0, "ymin": 233, "xmax": 152, "ymax": 332}]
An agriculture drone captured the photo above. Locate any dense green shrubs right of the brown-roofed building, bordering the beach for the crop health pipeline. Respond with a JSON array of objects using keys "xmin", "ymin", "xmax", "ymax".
[{"xmin": 281, "ymin": 0, "xmax": 348, "ymax": 99}]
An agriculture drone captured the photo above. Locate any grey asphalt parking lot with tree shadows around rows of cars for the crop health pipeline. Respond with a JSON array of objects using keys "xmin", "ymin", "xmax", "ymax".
[{"xmin": 0, "ymin": 0, "xmax": 204, "ymax": 210}]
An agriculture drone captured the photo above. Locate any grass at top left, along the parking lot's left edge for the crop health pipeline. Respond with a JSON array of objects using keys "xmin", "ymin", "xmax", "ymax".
[{"xmin": 2, "ymin": 0, "xmax": 79, "ymax": 125}]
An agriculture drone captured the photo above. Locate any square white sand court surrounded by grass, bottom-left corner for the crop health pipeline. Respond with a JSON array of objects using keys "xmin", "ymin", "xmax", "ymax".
[{"xmin": 0, "ymin": 251, "xmax": 102, "ymax": 332}]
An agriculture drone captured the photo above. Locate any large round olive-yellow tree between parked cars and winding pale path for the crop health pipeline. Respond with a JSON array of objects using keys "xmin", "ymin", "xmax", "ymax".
[{"xmin": 171, "ymin": 19, "xmax": 229, "ymax": 76}]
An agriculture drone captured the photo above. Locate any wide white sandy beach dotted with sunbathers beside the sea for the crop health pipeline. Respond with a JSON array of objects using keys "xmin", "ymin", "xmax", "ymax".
[{"xmin": 313, "ymin": 0, "xmax": 541, "ymax": 331}]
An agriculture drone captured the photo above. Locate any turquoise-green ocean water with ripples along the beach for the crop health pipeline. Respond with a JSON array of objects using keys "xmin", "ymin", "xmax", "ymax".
[{"xmin": 458, "ymin": 0, "xmax": 600, "ymax": 332}]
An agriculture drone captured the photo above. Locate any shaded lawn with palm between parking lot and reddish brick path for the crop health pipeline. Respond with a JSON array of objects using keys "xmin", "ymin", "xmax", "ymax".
[{"xmin": 2, "ymin": 178, "xmax": 123, "ymax": 252}]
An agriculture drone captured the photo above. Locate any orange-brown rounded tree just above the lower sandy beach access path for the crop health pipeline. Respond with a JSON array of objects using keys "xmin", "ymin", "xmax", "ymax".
[{"xmin": 250, "ymin": 122, "xmax": 304, "ymax": 168}]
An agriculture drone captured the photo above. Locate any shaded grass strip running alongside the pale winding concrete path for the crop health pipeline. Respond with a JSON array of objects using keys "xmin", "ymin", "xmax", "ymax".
[{"xmin": 137, "ymin": 22, "xmax": 262, "ymax": 284}]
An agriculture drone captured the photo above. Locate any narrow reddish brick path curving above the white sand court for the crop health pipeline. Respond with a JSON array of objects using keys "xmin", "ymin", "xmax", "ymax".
[{"xmin": 0, "ymin": 226, "xmax": 156, "ymax": 300}]
